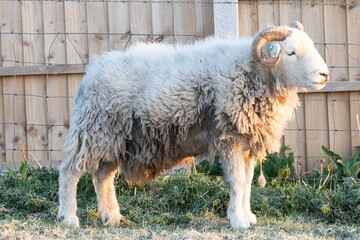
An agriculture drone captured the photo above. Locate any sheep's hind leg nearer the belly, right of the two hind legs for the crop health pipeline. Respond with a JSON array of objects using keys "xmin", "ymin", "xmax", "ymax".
[{"xmin": 93, "ymin": 162, "xmax": 122, "ymax": 226}]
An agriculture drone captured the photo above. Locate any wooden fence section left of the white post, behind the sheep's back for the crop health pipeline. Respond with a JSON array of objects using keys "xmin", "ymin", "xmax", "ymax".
[{"xmin": 0, "ymin": 1, "xmax": 214, "ymax": 169}]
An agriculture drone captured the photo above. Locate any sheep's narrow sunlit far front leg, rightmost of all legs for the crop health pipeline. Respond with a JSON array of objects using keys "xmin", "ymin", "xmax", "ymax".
[{"xmin": 243, "ymin": 151, "xmax": 256, "ymax": 224}]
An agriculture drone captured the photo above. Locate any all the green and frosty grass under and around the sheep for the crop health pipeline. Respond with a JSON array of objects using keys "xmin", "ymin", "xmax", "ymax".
[{"xmin": 0, "ymin": 161, "xmax": 360, "ymax": 239}]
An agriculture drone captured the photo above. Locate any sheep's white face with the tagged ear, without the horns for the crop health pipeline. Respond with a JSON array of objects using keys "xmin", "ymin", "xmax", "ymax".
[{"xmin": 264, "ymin": 28, "xmax": 329, "ymax": 90}]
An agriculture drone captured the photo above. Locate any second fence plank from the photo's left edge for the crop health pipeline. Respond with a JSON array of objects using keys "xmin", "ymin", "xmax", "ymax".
[{"xmin": 21, "ymin": 1, "xmax": 49, "ymax": 161}]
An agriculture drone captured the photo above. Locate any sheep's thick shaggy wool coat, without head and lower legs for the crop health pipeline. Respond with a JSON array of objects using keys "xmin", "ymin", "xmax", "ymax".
[{"xmin": 64, "ymin": 38, "xmax": 298, "ymax": 183}]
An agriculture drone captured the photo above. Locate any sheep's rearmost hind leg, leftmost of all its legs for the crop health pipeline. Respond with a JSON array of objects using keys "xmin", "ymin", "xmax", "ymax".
[{"xmin": 58, "ymin": 162, "xmax": 84, "ymax": 227}]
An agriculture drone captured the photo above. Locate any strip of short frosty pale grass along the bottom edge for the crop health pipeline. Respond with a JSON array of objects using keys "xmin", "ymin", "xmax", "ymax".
[{"xmin": 0, "ymin": 214, "xmax": 360, "ymax": 240}]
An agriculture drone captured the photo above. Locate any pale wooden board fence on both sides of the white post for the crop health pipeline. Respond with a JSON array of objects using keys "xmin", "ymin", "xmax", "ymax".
[{"xmin": 0, "ymin": 0, "xmax": 360, "ymax": 171}]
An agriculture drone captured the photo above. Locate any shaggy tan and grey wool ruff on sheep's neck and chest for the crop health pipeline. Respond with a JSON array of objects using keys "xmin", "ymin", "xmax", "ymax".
[{"xmin": 227, "ymin": 68, "xmax": 299, "ymax": 159}]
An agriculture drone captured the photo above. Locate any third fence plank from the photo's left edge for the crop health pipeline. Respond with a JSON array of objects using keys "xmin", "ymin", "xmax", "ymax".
[{"xmin": 43, "ymin": 2, "xmax": 69, "ymax": 163}]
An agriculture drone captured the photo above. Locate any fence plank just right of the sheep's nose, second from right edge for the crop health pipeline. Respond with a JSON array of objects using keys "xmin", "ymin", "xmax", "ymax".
[{"xmin": 324, "ymin": 0, "xmax": 351, "ymax": 161}]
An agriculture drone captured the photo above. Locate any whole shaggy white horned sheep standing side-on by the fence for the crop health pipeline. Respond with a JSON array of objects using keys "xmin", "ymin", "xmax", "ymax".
[{"xmin": 58, "ymin": 22, "xmax": 328, "ymax": 228}]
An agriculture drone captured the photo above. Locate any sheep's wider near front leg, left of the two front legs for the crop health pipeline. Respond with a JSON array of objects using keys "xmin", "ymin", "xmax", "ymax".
[{"xmin": 223, "ymin": 148, "xmax": 250, "ymax": 228}]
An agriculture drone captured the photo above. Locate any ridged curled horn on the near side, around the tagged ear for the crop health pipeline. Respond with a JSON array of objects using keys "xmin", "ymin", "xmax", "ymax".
[{"xmin": 251, "ymin": 27, "xmax": 291, "ymax": 68}]
